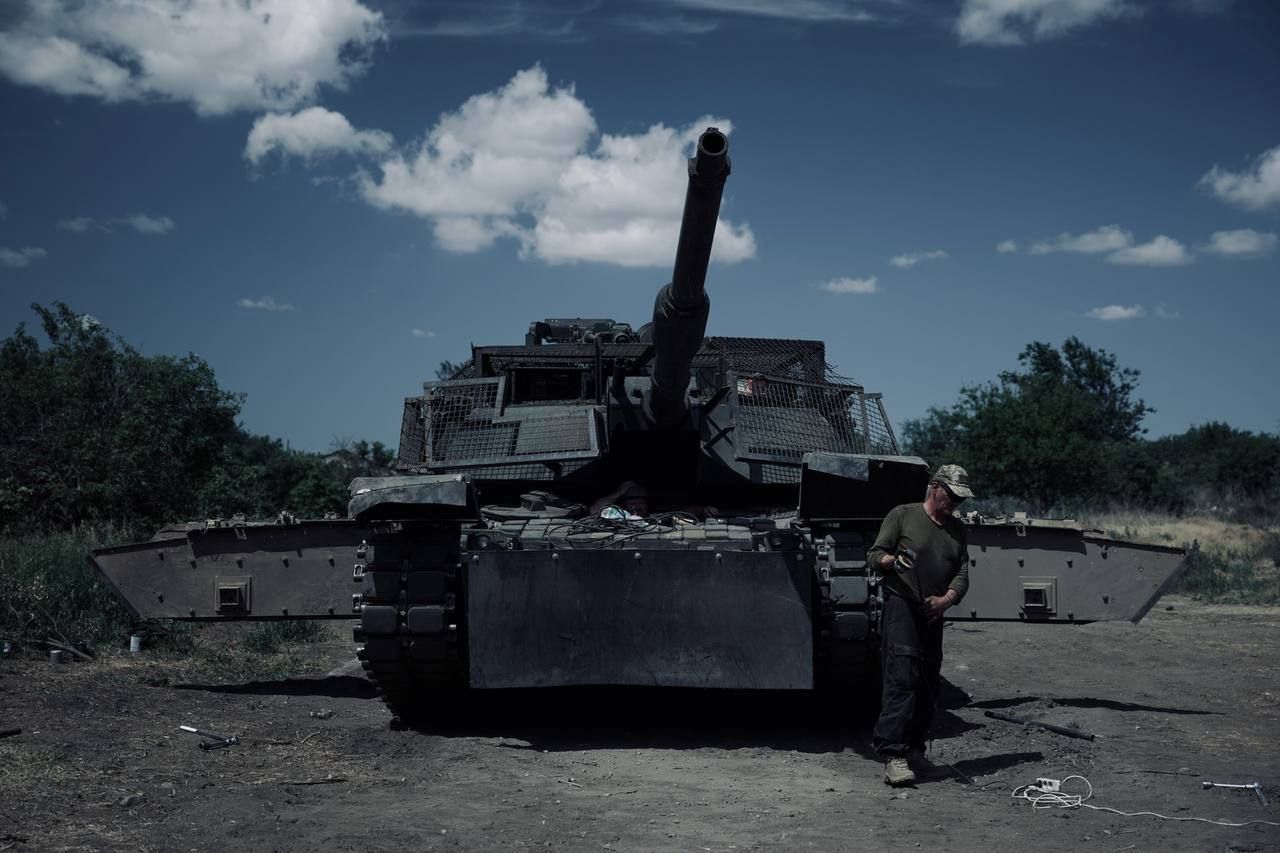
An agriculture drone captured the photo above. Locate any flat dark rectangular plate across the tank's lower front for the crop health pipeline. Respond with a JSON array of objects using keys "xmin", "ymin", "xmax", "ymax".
[{"xmin": 467, "ymin": 549, "xmax": 813, "ymax": 690}]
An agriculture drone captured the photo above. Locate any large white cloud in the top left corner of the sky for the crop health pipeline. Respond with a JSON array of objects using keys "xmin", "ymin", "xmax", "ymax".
[{"xmin": 0, "ymin": 0, "xmax": 385, "ymax": 115}]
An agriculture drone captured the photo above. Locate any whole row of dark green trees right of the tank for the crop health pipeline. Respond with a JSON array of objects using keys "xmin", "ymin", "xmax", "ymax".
[{"xmin": 902, "ymin": 337, "xmax": 1280, "ymax": 523}]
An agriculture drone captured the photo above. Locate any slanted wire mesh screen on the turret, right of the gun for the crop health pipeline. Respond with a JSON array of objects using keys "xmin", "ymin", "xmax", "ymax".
[{"xmin": 730, "ymin": 374, "xmax": 897, "ymax": 464}]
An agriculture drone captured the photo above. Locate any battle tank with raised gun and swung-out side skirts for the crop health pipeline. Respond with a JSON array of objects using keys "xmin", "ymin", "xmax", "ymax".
[{"xmin": 90, "ymin": 128, "xmax": 1184, "ymax": 725}]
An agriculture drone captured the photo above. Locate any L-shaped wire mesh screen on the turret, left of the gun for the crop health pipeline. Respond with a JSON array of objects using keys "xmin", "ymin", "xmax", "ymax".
[{"xmin": 421, "ymin": 377, "xmax": 599, "ymax": 470}]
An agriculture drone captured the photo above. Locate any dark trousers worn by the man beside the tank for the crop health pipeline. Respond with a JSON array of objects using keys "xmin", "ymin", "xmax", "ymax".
[{"xmin": 872, "ymin": 590, "xmax": 942, "ymax": 758}]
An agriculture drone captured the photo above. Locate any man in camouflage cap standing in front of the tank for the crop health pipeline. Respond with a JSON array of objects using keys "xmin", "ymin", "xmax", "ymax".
[{"xmin": 867, "ymin": 465, "xmax": 973, "ymax": 786}]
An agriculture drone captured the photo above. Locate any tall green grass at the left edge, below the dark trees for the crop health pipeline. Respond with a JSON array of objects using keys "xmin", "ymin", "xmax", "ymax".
[{"xmin": 0, "ymin": 526, "xmax": 132, "ymax": 644}]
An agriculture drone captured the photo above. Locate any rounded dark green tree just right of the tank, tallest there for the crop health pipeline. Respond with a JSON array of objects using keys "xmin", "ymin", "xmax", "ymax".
[{"xmin": 902, "ymin": 337, "xmax": 1153, "ymax": 512}]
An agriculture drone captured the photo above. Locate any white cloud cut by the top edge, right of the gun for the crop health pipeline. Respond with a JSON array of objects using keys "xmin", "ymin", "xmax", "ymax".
[{"xmin": 955, "ymin": 0, "xmax": 1138, "ymax": 46}]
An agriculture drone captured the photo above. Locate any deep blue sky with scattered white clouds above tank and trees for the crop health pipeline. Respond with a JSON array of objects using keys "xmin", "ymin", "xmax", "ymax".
[{"xmin": 0, "ymin": 0, "xmax": 1280, "ymax": 450}]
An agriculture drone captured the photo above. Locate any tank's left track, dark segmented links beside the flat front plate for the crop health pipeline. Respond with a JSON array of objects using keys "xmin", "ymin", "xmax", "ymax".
[{"xmin": 352, "ymin": 521, "xmax": 467, "ymax": 729}]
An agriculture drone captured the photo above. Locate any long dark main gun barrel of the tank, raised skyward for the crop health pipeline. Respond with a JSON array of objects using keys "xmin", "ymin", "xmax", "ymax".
[{"xmin": 644, "ymin": 127, "xmax": 730, "ymax": 427}]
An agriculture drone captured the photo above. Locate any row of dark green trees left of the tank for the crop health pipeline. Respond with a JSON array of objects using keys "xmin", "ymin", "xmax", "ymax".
[{"xmin": 0, "ymin": 302, "xmax": 393, "ymax": 535}]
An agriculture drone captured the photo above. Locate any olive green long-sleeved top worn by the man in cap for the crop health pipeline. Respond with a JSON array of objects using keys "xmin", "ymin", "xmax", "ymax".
[{"xmin": 867, "ymin": 503, "xmax": 969, "ymax": 603}]
